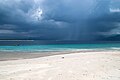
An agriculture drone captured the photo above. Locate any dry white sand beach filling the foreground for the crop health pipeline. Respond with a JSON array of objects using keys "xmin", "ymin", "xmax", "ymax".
[{"xmin": 0, "ymin": 51, "xmax": 120, "ymax": 80}]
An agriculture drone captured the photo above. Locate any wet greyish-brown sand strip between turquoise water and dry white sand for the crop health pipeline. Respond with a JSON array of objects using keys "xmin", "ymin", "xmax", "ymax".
[{"xmin": 0, "ymin": 49, "xmax": 119, "ymax": 61}]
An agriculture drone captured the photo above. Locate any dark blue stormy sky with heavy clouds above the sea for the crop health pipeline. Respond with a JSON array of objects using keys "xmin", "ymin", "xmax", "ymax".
[{"xmin": 0, "ymin": 0, "xmax": 120, "ymax": 42}]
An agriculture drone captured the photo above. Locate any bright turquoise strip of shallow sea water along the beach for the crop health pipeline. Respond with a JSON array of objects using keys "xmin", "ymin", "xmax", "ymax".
[{"xmin": 0, "ymin": 43, "xmax": 120, "ymax": 52}]
